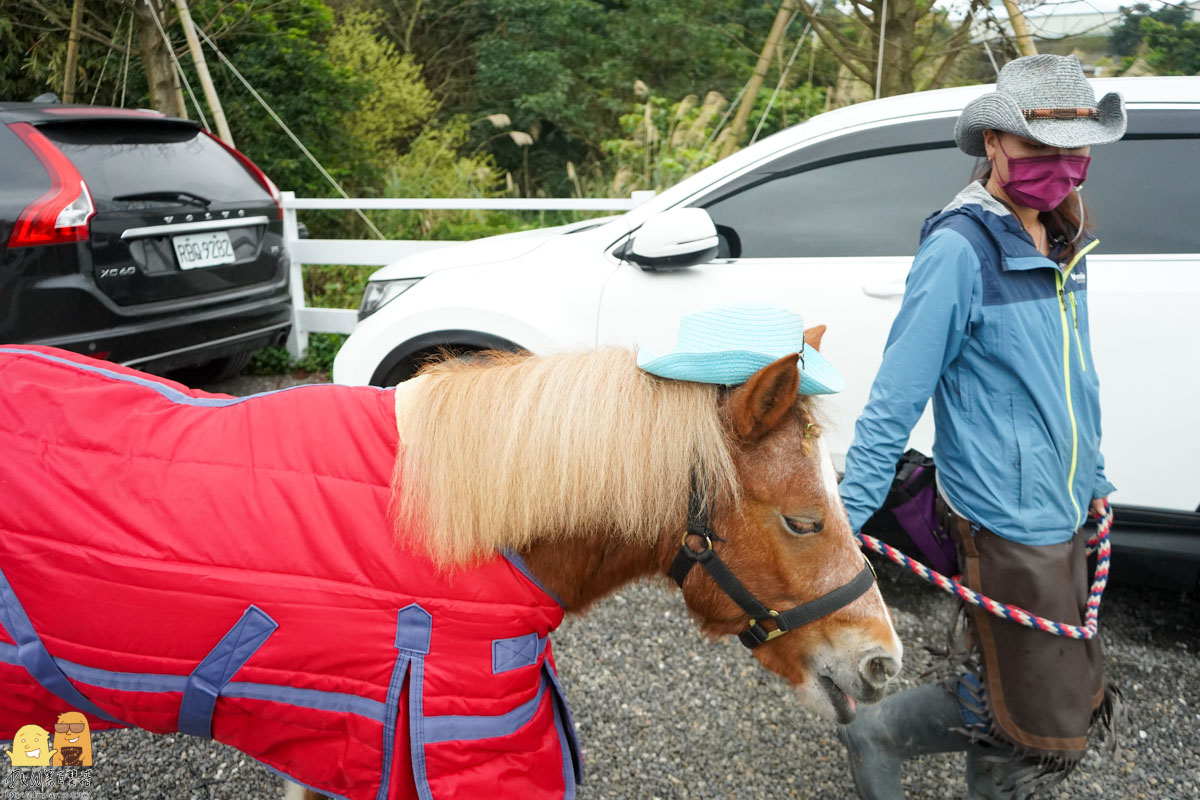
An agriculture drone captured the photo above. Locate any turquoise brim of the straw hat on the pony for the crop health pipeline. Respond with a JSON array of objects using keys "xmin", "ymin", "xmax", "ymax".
[{"xmin": 637, "ymin": 347, "xmax": 846, "ymax": 395}]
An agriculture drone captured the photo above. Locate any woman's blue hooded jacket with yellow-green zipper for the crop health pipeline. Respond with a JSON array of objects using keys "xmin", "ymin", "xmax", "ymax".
[{"xmin": 841, "ymin": 182, "xmax": 1114, "ymax": 545}]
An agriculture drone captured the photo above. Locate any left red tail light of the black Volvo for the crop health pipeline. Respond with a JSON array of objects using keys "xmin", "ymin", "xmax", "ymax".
[{"xmin": 8, "ymin": 122, "xmax": 96, "ymax": 247}]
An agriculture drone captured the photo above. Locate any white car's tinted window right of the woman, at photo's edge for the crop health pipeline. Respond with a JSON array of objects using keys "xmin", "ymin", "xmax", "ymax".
[{"xmin": 1084, "ymin": 138, "xmax": 1200, "ymax": 253}]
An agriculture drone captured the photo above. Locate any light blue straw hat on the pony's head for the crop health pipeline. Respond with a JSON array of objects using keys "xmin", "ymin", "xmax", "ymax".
[{"xmin": 637, "ymin": 303, "xmax": 846, "ymax": 395}]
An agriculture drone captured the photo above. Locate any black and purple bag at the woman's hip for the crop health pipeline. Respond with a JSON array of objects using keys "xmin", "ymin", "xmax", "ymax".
[{"xmin": 863, "ymin": 450, "xmax": 959, "ymax": 577}]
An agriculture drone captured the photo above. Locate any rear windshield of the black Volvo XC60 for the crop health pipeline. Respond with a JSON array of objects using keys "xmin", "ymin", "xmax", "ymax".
[{"xmin": 37, "ymin": 120, "xmax": 271, "ymax": 211}]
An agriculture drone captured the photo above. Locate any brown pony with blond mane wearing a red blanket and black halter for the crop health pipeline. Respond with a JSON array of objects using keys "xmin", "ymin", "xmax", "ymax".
[{"xmin": 0, "ymin": 327, "xmax": 901, "ymax": 800}]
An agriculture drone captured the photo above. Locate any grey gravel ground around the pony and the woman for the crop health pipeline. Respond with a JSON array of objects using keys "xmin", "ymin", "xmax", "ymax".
[{"xmin": 14, "ymin": 375, "xmax": 1200, "ymax": 800}]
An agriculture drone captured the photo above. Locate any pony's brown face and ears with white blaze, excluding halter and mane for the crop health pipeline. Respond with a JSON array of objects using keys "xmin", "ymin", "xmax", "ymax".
[{"xmin": 676, "ymin": 326, "xmax": 901, "ymax": 723}]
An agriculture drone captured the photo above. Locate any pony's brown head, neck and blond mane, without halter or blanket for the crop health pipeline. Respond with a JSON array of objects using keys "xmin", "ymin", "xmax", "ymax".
[{"xmin": 300, "ymin": 326, "xmax": 901, "ymax": 796}]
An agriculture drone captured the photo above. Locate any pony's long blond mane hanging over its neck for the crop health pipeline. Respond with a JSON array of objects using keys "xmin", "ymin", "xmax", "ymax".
[{"xmin": 392, "ymin": 348, "xmax": 738, "ymax": 565}]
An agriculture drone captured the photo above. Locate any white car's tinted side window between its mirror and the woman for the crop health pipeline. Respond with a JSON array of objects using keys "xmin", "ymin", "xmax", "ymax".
[{"xmin": 697, "ymin": 144, "xmax": 960, "ymax": 258}]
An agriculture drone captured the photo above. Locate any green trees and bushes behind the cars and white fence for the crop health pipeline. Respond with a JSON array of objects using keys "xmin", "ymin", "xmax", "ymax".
[{"xmin": 0, "ymin": 0, "xmax": 1200, "ymax": 376}]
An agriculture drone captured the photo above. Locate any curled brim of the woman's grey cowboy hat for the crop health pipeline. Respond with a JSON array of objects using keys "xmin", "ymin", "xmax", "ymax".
[{"xmin": 954, "ymin": 91, "xmax": 1126, "ymax": 157}]
